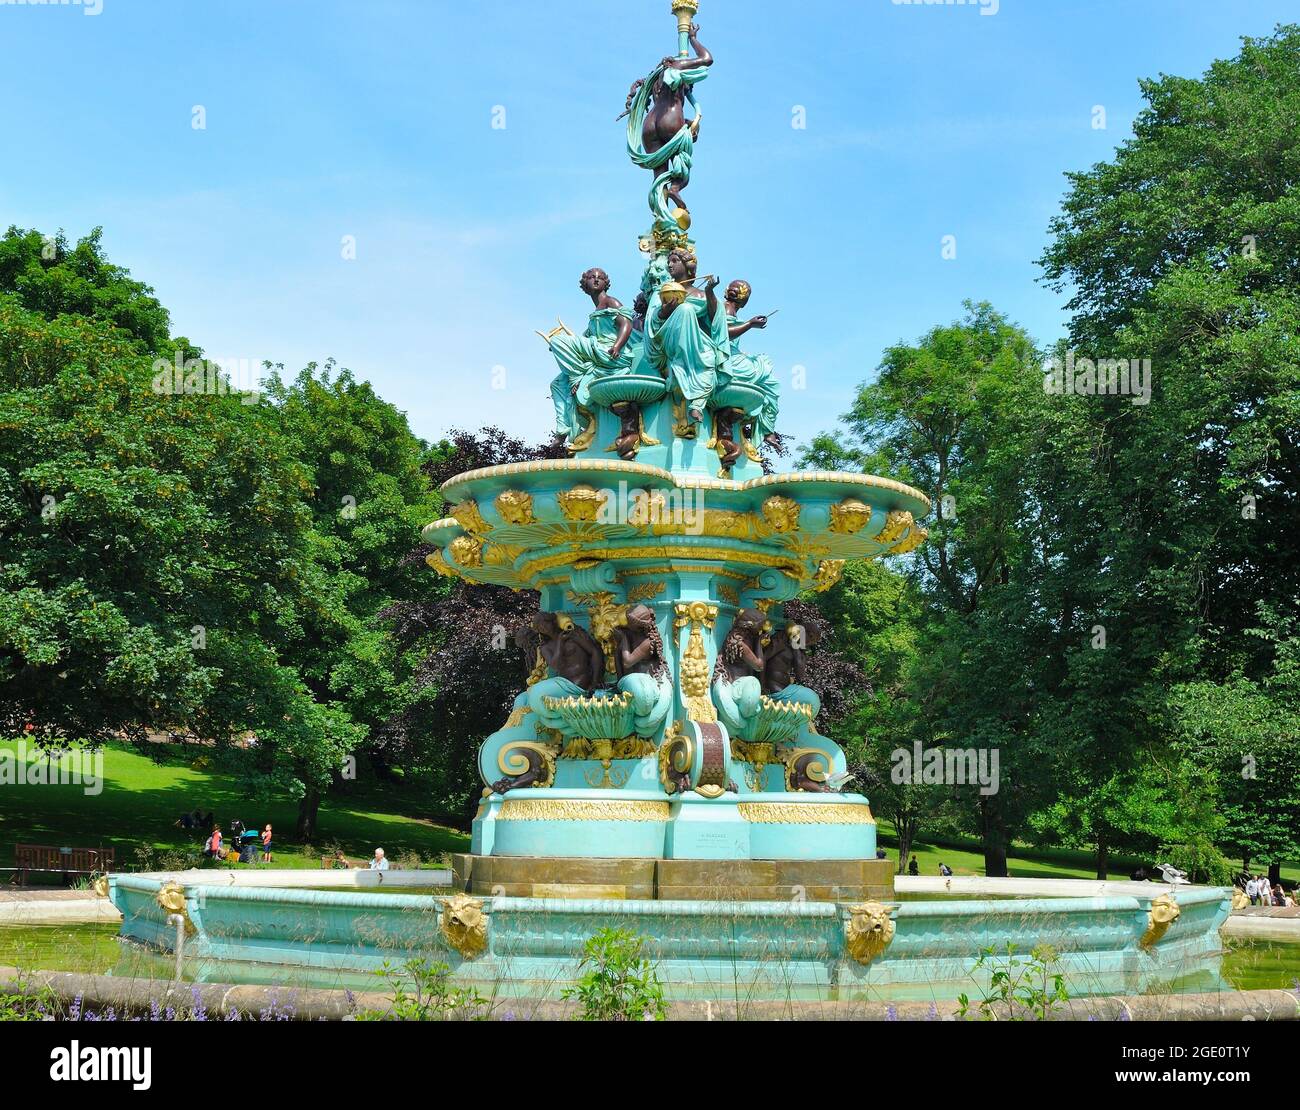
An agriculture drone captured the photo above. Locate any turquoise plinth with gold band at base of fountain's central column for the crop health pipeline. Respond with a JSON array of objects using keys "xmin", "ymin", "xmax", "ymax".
[{"xmin": 472, "ymin": 790, "xmax": 876, "ymax": 860}]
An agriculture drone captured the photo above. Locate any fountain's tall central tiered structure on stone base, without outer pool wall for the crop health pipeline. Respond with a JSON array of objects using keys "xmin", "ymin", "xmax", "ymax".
[{"xmin": 424, "ymin": 0, "xmax": 930, "ymax": 897}]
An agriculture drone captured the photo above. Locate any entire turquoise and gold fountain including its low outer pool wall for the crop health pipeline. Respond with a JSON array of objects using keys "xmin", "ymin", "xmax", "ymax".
[{"xmin": 111, "ymin": 0, "xmax": 1229, "ymax": 998}]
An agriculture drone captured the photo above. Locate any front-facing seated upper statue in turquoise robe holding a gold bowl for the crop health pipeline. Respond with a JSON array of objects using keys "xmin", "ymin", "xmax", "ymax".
[{"xmin": 645, "ymin": 248, "xmax": 731, "ymax": 425}]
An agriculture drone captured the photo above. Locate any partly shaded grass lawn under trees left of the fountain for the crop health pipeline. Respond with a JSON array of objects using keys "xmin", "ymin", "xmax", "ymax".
[{"xmin": 0, "ymin": 741, "xmax": 469, "ymax": 881}]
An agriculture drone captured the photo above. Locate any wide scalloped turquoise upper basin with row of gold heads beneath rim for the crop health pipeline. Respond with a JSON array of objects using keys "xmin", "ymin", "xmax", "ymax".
[{"xmin": 424, "ymin": 459, "xmax": 930, "ymax": 589}]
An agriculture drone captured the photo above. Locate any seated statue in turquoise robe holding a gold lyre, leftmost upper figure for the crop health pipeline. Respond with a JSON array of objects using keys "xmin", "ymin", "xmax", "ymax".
[{"xmin": 546, "ymin": 269, "xmax": 640, "ymax": 439}]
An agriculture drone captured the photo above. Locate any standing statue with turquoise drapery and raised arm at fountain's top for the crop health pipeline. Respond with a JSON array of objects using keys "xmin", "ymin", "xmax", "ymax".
[{"xmin": 619, "ymin": 23, "xmax": 714, "ymax": 229}]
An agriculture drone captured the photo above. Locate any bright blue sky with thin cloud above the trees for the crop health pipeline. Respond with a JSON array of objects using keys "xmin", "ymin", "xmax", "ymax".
[{"xmin": 0, "ymin": 0, "xmax": 1300, "ymax": 452}]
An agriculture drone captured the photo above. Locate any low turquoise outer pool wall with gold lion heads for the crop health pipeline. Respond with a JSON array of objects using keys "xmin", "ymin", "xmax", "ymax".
[{"xmin": 109, "ymin": 875, "xmax": 1230, "ymax": 1000}]
